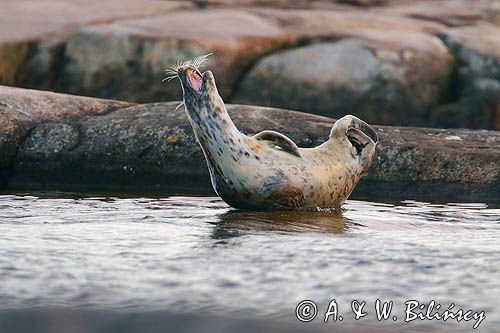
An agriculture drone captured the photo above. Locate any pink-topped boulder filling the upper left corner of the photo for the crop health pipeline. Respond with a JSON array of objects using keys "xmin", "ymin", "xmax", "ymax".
[{"xmin": 0, "ymin": 0, "xmax": 193, "ymax": 89}]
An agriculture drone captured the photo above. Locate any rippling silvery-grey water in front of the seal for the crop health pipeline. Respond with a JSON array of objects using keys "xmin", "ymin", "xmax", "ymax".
[{"xmin": 0, "ymin": 194, "xmax": 500, "ymax": 332}]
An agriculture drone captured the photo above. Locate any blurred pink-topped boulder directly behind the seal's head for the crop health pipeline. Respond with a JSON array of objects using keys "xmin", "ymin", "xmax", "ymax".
[{"xmin": 55, "ymin": 10, "xmax": 284, "ymax": 102}]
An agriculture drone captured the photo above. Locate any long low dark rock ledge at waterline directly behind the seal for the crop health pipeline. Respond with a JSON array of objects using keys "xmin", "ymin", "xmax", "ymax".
[{"xmin": 0, "ymin": 87, "xmax": 500, "ymax": 203}]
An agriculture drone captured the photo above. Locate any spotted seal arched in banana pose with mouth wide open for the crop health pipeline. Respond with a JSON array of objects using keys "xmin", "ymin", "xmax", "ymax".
[{"xmin": 166, "ymin": 56, "xmax": 378, "ymax": 210}]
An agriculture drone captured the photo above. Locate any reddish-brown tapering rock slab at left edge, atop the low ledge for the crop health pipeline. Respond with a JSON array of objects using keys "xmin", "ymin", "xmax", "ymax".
[{"xmin": 0, "ymin": 86, "xmax": 133, "ymax": 184}]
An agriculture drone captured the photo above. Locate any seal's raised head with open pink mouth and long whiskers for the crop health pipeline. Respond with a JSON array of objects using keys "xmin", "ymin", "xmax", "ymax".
[{"xmin": 165, "ymin": 54, "xmax": 225, "ymax": 123}]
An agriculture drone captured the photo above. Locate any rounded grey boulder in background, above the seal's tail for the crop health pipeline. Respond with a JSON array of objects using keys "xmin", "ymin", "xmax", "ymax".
[{"xmin": 233, "ymin": 33, "xmax": 452, "ymax": 125}]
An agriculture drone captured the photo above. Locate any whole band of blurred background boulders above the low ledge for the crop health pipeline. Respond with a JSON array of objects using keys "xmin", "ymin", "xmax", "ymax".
[{"xmin": 0, "ymin": 0, "xmax": 500, "ymax": 130}]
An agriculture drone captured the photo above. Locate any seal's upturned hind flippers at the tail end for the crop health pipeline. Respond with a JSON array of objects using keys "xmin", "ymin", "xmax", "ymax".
[{"xmin": 330, "ymin": 115, "xmax": 378, "ymax": 173}]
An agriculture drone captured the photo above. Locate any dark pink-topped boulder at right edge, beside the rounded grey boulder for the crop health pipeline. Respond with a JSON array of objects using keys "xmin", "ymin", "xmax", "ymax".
[{"xmin": 431, "ymin": 24, "xmax": 500, "ymax": 130}]
